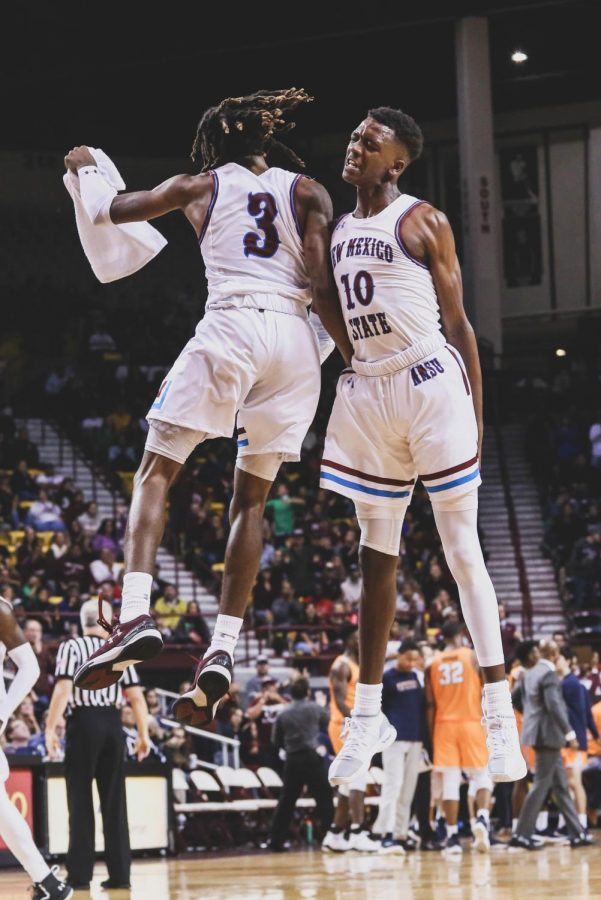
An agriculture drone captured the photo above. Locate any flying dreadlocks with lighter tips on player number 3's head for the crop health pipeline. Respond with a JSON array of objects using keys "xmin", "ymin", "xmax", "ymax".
[{"xmin": 191, "ymin": 88, "xmax": 313, "ymax": 172}]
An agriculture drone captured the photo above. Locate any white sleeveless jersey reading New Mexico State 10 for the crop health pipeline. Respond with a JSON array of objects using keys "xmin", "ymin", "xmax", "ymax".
[{"xmin": 331, "ymin": 194, "xmax": 440, "ymax": 362}]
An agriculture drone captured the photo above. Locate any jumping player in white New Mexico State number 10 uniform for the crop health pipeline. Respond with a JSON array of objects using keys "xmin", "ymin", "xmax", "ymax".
[{"xmin": 321, "ymin": 107, "xmax": 525, "ymax": 783}]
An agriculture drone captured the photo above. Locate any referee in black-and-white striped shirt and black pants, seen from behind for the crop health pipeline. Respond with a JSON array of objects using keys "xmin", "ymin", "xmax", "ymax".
[{"xmin": 45, "ymin": 600, "xmax": 150, "ymax": 889}]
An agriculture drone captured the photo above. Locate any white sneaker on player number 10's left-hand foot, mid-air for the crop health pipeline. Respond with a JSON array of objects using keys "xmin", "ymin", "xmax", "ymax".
[{"xmin": 328, "ymin": 712, "xmax": 396, "ymax": 784}]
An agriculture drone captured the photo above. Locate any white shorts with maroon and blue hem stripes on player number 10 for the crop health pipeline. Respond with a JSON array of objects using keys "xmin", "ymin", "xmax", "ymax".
[{"xmin": 320, "ymin": 341, "xmax": 481, "ymax": 510}]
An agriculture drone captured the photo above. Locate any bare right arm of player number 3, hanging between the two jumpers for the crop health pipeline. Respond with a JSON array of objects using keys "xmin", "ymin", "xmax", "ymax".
[{"xmin": 296, "ymin": 178, "xmax": 353, "ymax": 366}]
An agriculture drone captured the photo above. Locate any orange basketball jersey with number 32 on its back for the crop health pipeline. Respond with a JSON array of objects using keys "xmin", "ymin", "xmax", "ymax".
[{"xmin": 430, "ymin": 647, "xmax": 482, "ymax": 722}]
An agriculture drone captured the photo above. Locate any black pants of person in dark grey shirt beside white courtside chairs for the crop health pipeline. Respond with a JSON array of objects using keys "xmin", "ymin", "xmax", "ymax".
[{"xmin": 271, "ymin": 749, "xmax": 334, "ymax": 846}]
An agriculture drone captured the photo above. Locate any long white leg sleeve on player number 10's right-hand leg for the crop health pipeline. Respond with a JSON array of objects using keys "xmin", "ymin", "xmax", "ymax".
[{"xmin": 432, "ymin": 504, "xmax": 504, "ymax": 666}]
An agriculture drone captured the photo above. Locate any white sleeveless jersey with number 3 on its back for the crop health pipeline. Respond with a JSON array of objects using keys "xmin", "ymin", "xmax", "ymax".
[{"xmin": 199, "ymin": 163, "xmax": 311, "ymax": 309}]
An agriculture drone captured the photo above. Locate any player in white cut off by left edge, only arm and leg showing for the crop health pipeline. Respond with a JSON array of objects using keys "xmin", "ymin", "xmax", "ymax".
[{"xmin": 0, "ymin": 597, "xmax": 73, "ymax": 900}]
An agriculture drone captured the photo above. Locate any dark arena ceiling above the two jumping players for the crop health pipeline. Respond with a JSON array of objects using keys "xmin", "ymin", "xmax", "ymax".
[{"xmin": 0, "ymin": 0, "xmax": 601, "ymax": 156}]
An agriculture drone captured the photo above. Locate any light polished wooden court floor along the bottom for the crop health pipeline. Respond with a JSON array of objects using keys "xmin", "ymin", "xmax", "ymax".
[{"xmin": 0, "ymin": 844, "xmax": 601, "ymax": 900}]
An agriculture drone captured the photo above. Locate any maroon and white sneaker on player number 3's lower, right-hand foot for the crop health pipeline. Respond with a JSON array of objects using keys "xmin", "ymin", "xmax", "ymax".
[{"xmin": 171, "ymin": 650, "xmax": 234, "ymax": 728}]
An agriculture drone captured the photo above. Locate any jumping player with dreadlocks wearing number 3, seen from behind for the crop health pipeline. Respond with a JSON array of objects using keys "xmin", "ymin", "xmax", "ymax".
[{"xmin": 65, "ymin": 88, "xmax": 352, "ymax": 725}]
